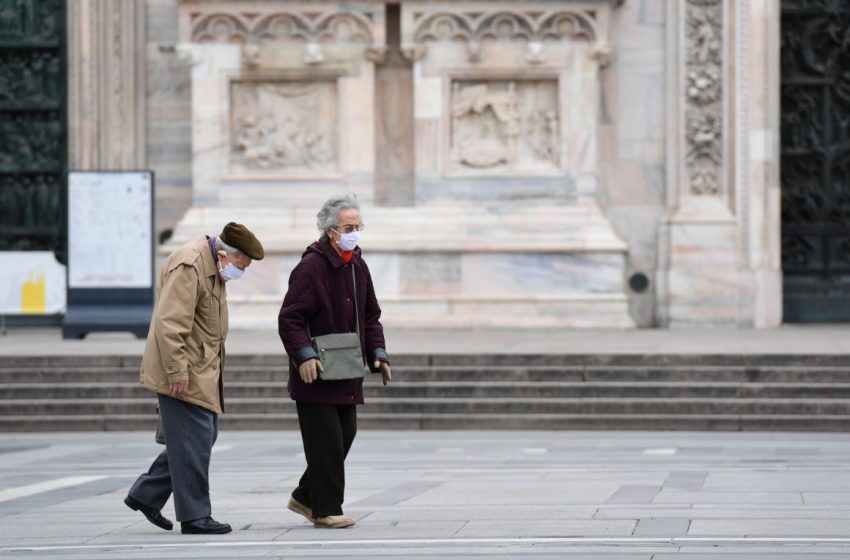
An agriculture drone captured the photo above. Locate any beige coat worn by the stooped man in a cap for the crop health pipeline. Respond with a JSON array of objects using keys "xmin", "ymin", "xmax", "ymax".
[{"xmin": 140, "ymin": 237, "xmax": 227, "ymax": 414}]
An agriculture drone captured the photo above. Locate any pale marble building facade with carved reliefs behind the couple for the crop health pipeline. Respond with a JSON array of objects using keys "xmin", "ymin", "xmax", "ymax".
[{"xmin": 69, "ymin": 0, "xmax": 782, "ymax": 328}]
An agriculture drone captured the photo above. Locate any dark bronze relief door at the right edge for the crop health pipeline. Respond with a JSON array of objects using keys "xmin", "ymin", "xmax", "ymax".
[{"xmin": 781, "ymin": 0, "xmax": 850, "ymax": 323}]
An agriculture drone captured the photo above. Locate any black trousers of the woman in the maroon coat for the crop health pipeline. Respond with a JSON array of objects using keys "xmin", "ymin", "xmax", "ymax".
[{"xmin": 292, "ymin": 402, "xmax": 357, "ymax": 517}]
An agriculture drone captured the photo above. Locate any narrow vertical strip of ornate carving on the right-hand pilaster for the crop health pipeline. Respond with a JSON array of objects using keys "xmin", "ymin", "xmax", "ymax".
[{"xmin": 685, "ymin": 0, "xmax": 723, "ymax": 195}]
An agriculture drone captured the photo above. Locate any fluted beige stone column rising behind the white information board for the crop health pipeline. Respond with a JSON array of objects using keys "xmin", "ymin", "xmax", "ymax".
[{"xmin": 68, "ymin": 0, "xmax": 146, "ymax": 169}]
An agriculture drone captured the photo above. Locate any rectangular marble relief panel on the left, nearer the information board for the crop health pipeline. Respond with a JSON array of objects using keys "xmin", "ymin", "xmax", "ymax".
[{"xmin": 230, "ymin": 81, "xmax": 338, "ymax": 176}]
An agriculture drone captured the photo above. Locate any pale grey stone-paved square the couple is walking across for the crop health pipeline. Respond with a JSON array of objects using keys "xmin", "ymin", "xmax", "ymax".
[{"xmin": 0, "ymin": 430, "xmax": 850, "ymax": 560}]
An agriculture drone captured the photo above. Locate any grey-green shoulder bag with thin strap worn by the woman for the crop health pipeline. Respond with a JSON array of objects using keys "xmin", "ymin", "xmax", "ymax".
[{"xmin": 307, "ymin": 264, "xmax": 369, "ymax": 381}]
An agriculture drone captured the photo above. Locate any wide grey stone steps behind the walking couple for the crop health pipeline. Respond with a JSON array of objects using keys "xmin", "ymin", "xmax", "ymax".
[{"xmin": 0, "ymin": 354, "xmax": 850, "ymax": 432}]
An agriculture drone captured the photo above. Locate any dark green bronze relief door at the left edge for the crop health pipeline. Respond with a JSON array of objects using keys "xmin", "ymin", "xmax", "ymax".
[{"xmin": 0, "ymin": 0, "xmax": 68, "ymax": 255}]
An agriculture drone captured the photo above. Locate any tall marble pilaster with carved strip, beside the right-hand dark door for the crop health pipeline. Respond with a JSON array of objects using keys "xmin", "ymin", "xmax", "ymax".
[{"xmin": 658, "ymin": 0, "xmax": 781, "ymax": 327}]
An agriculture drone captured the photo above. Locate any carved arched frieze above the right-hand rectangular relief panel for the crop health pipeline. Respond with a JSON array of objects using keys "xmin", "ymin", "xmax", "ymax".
[{"xmin": 413, "ymin": 10, "xmax": 602, "ymax": 64}]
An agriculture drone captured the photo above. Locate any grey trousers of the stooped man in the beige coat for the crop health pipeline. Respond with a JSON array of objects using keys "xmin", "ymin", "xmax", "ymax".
[{"xmin": 128, "ymin": 395, "xmax": 218, "ymax": 521}]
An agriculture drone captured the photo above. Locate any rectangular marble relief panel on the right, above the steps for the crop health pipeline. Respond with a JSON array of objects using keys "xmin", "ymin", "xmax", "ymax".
[{"xmin": 448, "ymin": 80, "xmax": 561, "ymax": 176}]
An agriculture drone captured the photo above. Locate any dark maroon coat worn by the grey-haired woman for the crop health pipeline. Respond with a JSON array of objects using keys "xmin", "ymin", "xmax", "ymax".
[{"xmin": 277, "ymin": 241, "xmax": 388, "ymax": 405}]
